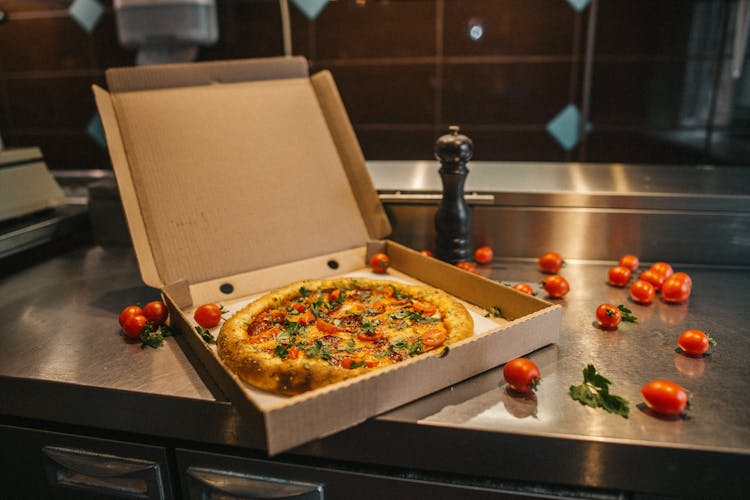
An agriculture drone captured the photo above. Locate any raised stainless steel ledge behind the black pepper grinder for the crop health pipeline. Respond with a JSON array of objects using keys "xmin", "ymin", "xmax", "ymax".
[{"xmin": 368, "ymin": 161, "xmax": 750, "ymax": 211}]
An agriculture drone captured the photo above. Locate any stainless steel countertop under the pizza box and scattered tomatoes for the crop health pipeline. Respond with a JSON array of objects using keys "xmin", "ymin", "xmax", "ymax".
[{"xmin": 0, "ymin": 247, "xmax": 750, "ymax": 496}]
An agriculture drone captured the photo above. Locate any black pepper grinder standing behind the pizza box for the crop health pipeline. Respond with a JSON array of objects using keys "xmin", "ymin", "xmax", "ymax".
[{"xmin": 435, "ymin": 125, "xmax": 474, "ymax": 264}]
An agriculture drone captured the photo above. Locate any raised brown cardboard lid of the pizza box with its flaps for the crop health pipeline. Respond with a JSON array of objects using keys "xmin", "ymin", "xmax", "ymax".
[{"xmin": 94, "ymin": 58, "xmax": 390, "ymax": 287}]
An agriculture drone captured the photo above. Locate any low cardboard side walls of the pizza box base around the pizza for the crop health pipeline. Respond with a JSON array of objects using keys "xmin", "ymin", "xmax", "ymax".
[{"xmin": 165, "ymin": 241, "xmax": 562, "ymax": 455}]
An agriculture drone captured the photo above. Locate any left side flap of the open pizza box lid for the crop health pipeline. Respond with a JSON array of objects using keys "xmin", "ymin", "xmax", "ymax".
[{"xmin": 91, "ymin": 85, "xmax": 164, "ymax": 288}]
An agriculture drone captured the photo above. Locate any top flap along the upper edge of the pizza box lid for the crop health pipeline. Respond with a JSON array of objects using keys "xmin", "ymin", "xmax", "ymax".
[{"xmin": 105, "ymin": 57, "xmax": 308, "ymax": 93}]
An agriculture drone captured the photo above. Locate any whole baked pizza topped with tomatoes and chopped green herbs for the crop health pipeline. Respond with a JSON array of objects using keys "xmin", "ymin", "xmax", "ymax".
[{"xmin": 216, "ymin": 277, "xmax": 474, "ymax": 395}]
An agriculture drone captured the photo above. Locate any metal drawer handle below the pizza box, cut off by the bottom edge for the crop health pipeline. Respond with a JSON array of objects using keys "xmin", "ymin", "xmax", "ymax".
[{"xmin": 187, "ymin": 467, "xmax": 323, "ymax": 500}]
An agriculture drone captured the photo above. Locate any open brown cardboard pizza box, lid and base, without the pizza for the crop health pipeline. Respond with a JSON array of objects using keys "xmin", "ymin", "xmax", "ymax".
[{"xmin": 94, "ymin": 58, "xmax": 561, "ymax": 454}]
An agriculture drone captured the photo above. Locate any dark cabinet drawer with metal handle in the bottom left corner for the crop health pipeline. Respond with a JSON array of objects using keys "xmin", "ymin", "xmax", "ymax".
[{"xmin": 0, "ymin": 425, "xmax": 173, "ymax": 500}]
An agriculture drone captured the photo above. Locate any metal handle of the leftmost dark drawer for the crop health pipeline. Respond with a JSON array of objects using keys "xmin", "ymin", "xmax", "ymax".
[{"xmin": 42, "ymin": 446, "xmax": 164, "ymax": 499}]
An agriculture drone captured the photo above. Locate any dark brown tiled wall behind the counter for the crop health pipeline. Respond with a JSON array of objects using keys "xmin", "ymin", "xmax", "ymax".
[{"xmin": 0, "ymin": 0, "xmax": 750, "ymax": 169}]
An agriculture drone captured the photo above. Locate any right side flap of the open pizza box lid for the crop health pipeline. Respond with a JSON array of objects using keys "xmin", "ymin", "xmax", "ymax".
[{"xmin": 310, "ymin": 70, "xmax": 391, "ymax": 239}]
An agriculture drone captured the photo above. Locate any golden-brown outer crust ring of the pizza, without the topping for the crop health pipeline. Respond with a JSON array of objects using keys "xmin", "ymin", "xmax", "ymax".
[{"xmin": 216, "ymin": 278, "xmax": 474, "ymax": 395}]
